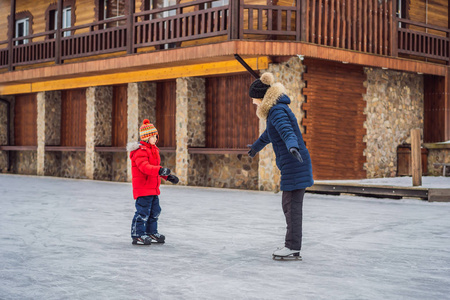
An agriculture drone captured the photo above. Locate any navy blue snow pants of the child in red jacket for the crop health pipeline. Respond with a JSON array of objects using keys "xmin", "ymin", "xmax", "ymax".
[{"xmin": 131, "ymin": 196, "xmax": 161, "ymax": 238}]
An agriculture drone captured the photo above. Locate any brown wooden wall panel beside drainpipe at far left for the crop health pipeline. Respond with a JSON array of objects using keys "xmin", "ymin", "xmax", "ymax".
[{"xmin": 14, "ymin": 93, "xmax": 37, "ymax": 146}]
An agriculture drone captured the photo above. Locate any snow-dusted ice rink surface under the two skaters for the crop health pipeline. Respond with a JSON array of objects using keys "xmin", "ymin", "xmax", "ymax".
[{"xmin": 0, "ymin": 175, "xmax": 450, "ymax": 300}]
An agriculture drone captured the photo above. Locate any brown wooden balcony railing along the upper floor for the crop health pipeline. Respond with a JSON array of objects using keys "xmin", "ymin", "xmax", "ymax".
[{"xmin": 0, "ymin": 0, "xmax": 450, "ymax": 70}]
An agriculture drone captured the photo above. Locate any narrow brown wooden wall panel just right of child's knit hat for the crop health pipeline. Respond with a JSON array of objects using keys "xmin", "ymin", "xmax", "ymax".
[{"xmin": 155, "ymin": 80, "xmax": 177, "ymax": 147}]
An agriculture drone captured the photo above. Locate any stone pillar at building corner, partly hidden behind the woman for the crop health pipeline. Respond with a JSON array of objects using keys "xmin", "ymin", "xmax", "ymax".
[{"xmin": 258, "ymin": 57, "xmax": 305, "ymax": 191}]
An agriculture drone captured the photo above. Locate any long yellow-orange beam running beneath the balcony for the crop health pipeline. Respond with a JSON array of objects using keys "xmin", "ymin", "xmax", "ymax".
[{"xmin": 0, "ymin": 57, "xmax": 269, "ymax": 95}]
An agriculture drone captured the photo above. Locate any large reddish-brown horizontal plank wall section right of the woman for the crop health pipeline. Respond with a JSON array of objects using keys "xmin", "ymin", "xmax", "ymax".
[{"xmin": 302, "ymin": 59, "xmax": 366, "ymax": 180}]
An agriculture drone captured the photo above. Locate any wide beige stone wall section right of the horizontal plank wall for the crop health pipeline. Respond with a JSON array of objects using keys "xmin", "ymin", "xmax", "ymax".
[{"xmin": 363, "ymin": 68, "xmax": 424, "ymax": 178}]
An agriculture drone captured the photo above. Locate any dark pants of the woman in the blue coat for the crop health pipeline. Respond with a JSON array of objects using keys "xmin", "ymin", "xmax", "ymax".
[{"xmin": 282, "ymin": 189, "xmax": 305, "ymax": 250}]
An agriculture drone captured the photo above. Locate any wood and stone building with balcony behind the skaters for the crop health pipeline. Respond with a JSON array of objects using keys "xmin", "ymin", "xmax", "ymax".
[{"xmin": 0, "ymin": 0, "xmax": 450, "ymax": 190}]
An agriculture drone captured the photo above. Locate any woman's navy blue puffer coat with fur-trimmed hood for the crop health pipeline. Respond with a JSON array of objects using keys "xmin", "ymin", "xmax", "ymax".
[{"xmin": 252, "ymin": 83, "xmax": 314, "ymax": 191}]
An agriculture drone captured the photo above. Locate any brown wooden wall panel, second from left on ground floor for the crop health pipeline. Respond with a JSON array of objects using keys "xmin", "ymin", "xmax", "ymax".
[{"xmin": 61, "ymin": 89, "xmax": 86, "ymax": 147}]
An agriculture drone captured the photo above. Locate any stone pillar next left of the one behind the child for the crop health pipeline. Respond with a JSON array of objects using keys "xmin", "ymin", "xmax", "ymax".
[{"xmin": 86, "ymin": 86, "xmax": 112, "ymax": 180}]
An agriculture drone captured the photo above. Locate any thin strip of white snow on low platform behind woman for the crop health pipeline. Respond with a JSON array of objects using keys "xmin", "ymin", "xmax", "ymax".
[{"xmin": 315, "ymin": 176, "xmax": 450, "ymax": 189}]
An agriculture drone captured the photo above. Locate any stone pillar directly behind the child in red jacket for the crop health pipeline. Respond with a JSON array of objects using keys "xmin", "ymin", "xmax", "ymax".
[{"xmin": 127, "ymin": 82, "xmax": 156, "ymax": 182}]
